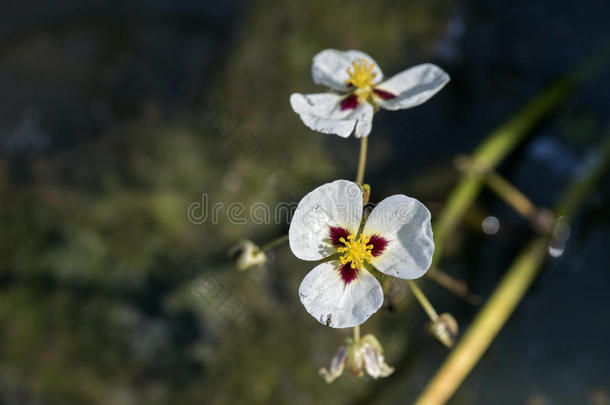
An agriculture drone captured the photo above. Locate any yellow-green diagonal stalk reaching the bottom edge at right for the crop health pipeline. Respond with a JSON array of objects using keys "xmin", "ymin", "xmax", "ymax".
[{"xmin": 415, "ymin": 133, "xmax": 610, "ymax": 405}]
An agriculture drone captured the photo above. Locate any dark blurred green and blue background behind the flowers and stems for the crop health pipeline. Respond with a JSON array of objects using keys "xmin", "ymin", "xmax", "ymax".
[{"xmin": 0, "ymin": 0, "xmax": 610, "ymax": 405}]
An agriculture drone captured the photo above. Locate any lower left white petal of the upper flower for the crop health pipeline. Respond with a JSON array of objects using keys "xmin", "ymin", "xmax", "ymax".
[{"xmin": 290, "ymin": 93, "xmax": 372, "ymax": 138}]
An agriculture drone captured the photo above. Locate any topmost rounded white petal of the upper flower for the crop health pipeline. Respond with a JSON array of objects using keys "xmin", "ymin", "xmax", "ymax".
[{"xmin": 311, "ymin": 49, "xmax": 383, "ymax": 91}]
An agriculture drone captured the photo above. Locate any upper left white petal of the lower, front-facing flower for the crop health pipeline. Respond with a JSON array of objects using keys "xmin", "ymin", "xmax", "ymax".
[{"xmin": 288, "ymin": 180, "xmax": 363, "ymax": 260}]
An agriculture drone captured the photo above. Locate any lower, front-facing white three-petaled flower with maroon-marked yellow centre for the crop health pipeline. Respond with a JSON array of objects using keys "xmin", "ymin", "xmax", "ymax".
[{"xmin": 288, "ymin": 180, "xmax": 434, "ymax": 328}]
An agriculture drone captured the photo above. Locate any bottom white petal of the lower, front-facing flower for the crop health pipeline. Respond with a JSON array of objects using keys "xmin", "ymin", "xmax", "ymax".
[{"xmin": 299, "ymin": 262, "xmax": 383, "ymax": 328}]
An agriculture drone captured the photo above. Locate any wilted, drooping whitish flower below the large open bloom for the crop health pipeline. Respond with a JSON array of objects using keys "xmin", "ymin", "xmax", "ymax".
[{"xmin": 319, "ymin": 335, "xmax": 394, "ymax": 384}]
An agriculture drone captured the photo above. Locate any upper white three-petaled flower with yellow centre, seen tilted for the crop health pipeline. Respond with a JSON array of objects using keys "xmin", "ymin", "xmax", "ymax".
[{"xmin": 290, "ymin": 49, "xmax": 449, "ymax": 138}]
